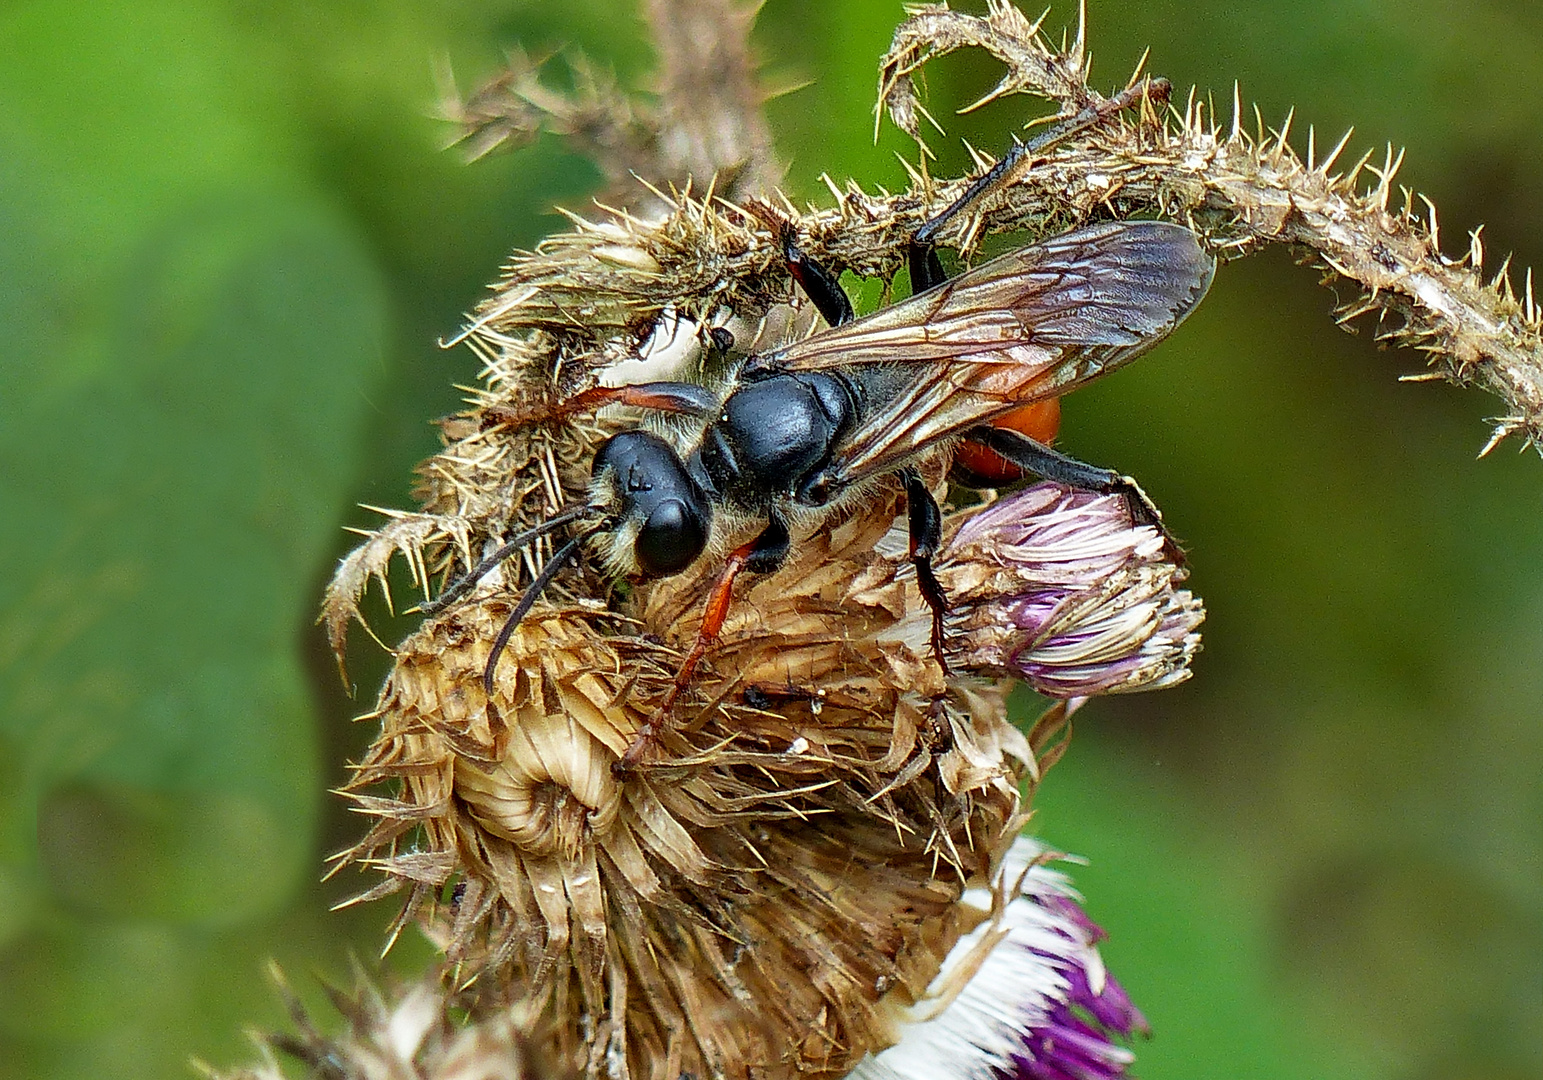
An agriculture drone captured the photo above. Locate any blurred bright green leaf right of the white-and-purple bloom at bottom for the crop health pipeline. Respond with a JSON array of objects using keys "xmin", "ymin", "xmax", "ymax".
[{"xmin": 1032, "ymin": 739, "xmax": 1378, "ymax": 1080}]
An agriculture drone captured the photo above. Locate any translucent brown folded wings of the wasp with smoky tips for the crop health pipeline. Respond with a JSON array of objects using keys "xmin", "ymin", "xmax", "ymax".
[{"xmin": 745, "ymin": 221, "xmax": 1216, "ymax": 488}]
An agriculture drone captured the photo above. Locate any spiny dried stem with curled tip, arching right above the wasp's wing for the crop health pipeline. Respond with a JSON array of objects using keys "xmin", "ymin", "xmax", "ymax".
[{"xmin": 880, "ymin": 0, "xmax": 1543, "ymax": 454}]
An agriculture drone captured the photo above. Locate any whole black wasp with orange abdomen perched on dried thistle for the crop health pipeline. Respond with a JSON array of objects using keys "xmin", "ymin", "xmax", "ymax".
[{"xmin": 424, "ymin": 91, "xmax": 1214, "ymax": 768}]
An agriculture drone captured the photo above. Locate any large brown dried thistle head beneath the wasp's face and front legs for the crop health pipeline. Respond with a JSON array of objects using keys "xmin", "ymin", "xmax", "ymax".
[{"xmin": 339, "ymin": 484, "xmax": 1034, "ymax": 1077}]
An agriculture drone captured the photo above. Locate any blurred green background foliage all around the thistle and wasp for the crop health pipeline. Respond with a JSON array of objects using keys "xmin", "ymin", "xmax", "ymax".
[{"xmin": 0, "ymin": 0, "xmax": 1543, "ymax": 1080}]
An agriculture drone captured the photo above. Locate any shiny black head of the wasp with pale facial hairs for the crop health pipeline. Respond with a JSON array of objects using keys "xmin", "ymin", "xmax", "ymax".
[{"xmin": 593, "ymin": 430, "xmax": 713, "ymax": 577}]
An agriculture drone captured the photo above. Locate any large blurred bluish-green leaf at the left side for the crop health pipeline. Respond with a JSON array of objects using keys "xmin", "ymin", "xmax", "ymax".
[{"xmin": 0, "ymin": 183, "xmax": 383, "ymax": 881}]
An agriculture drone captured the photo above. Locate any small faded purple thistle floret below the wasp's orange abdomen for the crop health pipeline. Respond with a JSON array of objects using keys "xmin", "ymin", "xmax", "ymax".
[{"xmin": 937, "ymin": 483, "xmax": 1205, "ymax": 697}]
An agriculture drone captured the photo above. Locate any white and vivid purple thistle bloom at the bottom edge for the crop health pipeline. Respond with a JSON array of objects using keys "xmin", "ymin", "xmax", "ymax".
[{"xmin": 847, "ymin": 838, "xmax": 1146, "ymax": 1080}]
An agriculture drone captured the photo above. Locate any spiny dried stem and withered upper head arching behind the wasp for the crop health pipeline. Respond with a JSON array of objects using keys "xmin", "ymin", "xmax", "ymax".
[{"xmin": 324, "ymin": 0, "xmax": 1543, "ymax": 688}]
